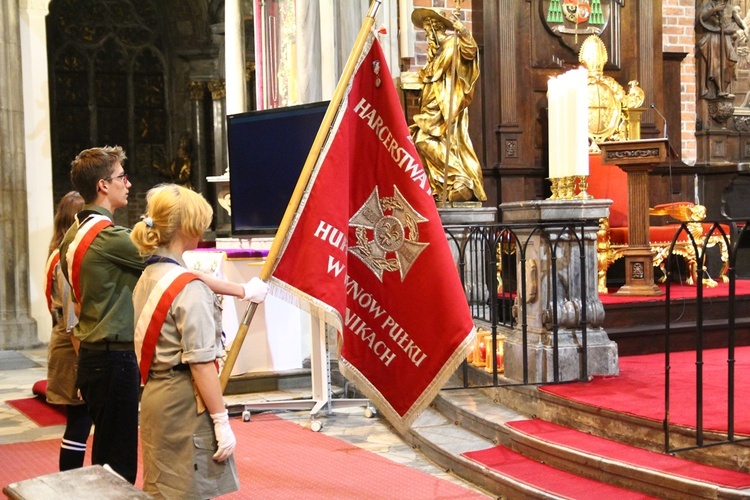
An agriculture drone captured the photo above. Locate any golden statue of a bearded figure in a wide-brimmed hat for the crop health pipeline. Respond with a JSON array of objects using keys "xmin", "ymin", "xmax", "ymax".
[{"xmin": 410, "ymin": 8, "xmax": 487, "ymax": 202}]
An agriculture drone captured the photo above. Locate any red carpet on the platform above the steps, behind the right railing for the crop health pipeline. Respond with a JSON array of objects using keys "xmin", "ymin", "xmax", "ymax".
[{"xmin": 539, "ymin": 347, "xmax": 750, "ymax": 435}]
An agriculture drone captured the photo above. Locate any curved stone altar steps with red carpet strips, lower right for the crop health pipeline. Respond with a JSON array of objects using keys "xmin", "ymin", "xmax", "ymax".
[{"xmin": 404, "ymin": 387, "xmax": 750, "ymax": 498}]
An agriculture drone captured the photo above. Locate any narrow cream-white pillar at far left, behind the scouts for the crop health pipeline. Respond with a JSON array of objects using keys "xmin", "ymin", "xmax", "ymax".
[{"xmin": 19, "ymin": 0, "xmax": 56, "ymax": 342}]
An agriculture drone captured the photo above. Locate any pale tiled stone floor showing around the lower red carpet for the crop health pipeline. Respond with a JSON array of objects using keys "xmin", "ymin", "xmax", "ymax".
[{"xmin": 0, "ymin": 348, "xmax": 494, "ymax": 493}]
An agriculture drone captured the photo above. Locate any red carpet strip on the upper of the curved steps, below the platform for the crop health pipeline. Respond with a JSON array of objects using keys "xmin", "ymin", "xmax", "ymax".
[{"xmin": 506, "ymin": 419, "xmax": 750, "ymax": 489}]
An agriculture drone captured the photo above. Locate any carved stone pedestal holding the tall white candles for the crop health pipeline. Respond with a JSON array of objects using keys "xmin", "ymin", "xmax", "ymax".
[{"xmin": 500, "ymin": 200, "xmax": 619, "ymax": 383}]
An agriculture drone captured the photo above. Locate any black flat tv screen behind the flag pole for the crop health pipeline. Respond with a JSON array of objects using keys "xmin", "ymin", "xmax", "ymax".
[{"xmin": 227, "ymin": 101, "xmax": 328, "ymax": 235}]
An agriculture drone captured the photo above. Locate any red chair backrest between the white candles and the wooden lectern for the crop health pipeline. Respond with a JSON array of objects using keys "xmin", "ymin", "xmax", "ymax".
[{"xmin": 587, "ymin": 154, "xmax": 628, "ymax": 227}]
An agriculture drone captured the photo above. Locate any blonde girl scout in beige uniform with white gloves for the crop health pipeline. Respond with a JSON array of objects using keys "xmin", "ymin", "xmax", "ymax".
[{"xmin": 132, "ymin": 184, "xmax": 266, "ymax": 498}]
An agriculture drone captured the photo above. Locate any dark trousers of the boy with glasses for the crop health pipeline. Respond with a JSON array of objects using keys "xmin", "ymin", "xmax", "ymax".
[{"xmin": 76, "ymin": 347, "xmax": 140, "ymax": 484}]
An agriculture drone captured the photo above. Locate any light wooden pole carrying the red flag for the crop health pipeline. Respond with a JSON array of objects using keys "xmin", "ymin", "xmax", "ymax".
[{"xmin": 219, "ymin": 0, "xmax": 382, "ymax": 392}]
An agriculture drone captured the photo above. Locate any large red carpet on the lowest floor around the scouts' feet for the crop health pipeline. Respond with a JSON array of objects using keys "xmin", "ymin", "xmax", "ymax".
[{"xmin": 0, "ymin": 415, "xmax": 484, "ymax": 500}]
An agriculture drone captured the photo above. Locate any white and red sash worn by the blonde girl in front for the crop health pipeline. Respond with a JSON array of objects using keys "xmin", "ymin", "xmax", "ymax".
[{"xmin": 135, "ymin": 266, "xmax": 198, "ymax": 384}]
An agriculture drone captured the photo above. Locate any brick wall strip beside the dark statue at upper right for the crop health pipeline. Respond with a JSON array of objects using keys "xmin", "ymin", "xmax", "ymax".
[{"xmin": 662, "ymin": 0, "xmax": 697, "ymax": 164}]
